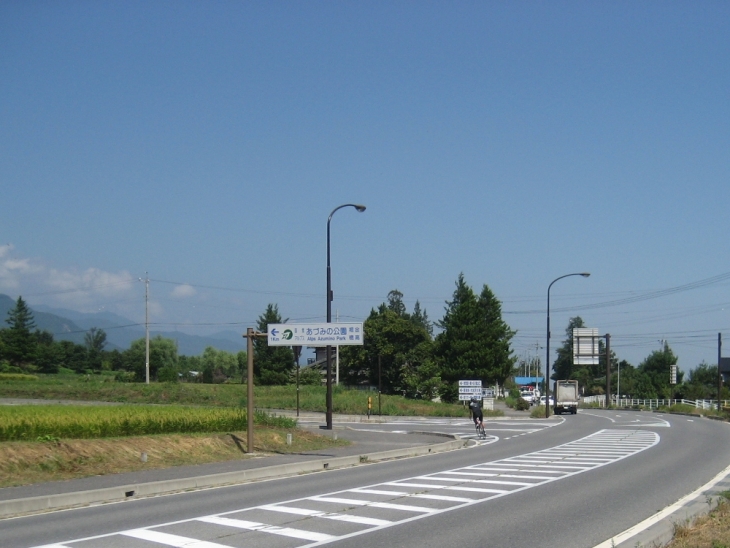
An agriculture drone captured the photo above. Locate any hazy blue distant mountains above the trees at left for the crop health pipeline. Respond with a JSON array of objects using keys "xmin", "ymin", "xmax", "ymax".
[{"xmin": 0, "ymin": 293, "xmax": 246, "ymax": 356}]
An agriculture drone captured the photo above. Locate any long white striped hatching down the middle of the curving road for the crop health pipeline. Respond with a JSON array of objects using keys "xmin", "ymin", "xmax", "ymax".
[{"xmin": 29, "ymin": 430, "xmax": 660, "ymax": 548}]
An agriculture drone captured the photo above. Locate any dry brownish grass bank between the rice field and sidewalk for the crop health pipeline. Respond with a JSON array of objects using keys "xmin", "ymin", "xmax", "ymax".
[{"xmin": 0, "ymin": 427, "xmax": 349, "ymax": 488}]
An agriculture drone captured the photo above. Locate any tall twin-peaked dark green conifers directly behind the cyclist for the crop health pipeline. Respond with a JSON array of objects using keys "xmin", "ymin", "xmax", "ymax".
[{"xmin": 435, "ymin": 274, "xmax": 516, "ymax": 401}]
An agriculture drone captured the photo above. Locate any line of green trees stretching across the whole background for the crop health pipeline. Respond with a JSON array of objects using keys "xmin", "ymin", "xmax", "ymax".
[{"xmin": 0, "ymin": 280, "xmax": 730, "ymax": 401}]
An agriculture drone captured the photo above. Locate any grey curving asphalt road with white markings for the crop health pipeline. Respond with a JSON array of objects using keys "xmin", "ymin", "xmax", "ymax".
[{"xmin": 0, "ymin": 410, "xmax": 730, "ymax": 548}]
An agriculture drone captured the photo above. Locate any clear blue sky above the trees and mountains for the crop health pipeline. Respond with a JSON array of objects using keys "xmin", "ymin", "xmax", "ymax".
[{"xmin": 0, "ymin": 1, "xmax": 730, "ymax": 370}]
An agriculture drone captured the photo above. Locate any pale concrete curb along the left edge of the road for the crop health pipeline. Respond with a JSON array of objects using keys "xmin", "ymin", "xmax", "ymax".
[{"xmin": 0, "ymin": 436, "xmax": 468, "ymax": 518}]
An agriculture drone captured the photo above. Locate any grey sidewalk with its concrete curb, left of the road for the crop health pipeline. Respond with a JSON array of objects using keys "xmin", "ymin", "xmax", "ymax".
[{"xmin": 0, "ymin": 411, "xmax": 467, "ymax": 518}]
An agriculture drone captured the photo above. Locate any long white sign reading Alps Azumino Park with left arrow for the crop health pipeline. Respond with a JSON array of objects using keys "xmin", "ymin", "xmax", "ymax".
[{"xmin": 267, "ymin": 322, "xmax": 365, "ymax": 346}]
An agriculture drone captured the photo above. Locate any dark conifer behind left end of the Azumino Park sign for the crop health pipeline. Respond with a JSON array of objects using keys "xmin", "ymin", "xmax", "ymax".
[{"xmin": 253, "ymin": 304, "xmax": 294, "ymax": 386}]
